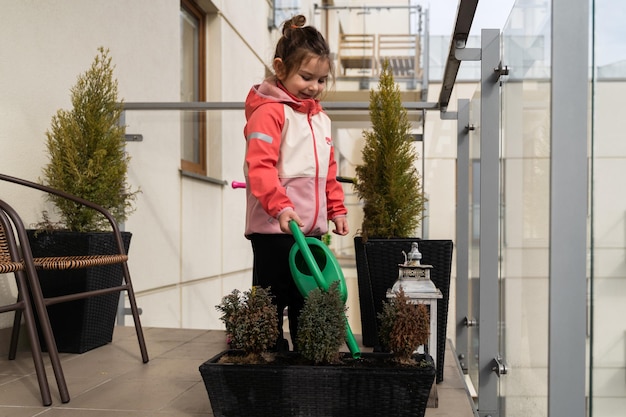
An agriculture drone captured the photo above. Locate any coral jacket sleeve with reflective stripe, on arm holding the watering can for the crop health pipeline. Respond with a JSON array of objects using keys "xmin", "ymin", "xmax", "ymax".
[{"xmin": 244, "ymin": 103, "xmax": 293, "ymax": 218}]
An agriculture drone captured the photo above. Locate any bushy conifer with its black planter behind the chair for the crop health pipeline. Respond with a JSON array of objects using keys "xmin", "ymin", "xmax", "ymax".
[{"xmin": 29, "ymin": 47, "xmax": 138, "ymax": 353}]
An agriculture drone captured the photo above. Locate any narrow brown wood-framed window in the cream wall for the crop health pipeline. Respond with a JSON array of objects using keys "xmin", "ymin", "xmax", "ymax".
[{"xmin": 180, "ymin": 0, "xmax": 207, "ymax": 175}]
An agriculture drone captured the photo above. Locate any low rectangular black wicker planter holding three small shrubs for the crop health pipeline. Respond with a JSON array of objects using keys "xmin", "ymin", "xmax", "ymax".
[{"xmin": 200, "ymin": 351, "xmax": 435, "ymax": 417}]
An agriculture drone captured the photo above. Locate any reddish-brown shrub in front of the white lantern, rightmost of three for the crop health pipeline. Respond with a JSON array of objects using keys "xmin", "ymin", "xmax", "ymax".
[{"xmin": 378, "ymin": 288, "xmax": 430, "ymax": 363}]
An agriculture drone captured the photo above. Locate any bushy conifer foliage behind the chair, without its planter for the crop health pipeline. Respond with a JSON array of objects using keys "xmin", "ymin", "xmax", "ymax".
[{"xmin": 43, "ymin": 47, "xmax": 138, "ymax": 231}]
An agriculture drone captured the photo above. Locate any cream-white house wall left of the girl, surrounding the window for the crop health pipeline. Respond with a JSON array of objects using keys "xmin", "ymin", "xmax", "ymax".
[{"xmin": 0, "ymin": 0, "xmax": 264, "ymax": 328}]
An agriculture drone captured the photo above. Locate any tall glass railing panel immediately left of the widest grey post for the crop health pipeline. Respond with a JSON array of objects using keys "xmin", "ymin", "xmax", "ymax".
[{"xmin": 499, "ymin": 0, "xmax": 550, "ymax": 416}]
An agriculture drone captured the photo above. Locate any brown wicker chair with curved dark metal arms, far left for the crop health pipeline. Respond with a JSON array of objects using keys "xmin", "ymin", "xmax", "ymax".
[{"xmin": 0, "ymin": 174, "xmax": 149, "ymax": 403}]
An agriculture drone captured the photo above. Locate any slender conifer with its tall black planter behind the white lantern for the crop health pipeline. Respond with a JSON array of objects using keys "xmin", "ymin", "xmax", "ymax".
[{"xmin": 354, "ymin": 61, "xmax": 452, "ymax": 381}]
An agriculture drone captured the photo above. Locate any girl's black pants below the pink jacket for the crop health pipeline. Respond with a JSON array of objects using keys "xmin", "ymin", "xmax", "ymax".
[{"xmin": 249, "ymin": 234, "xmax": 304, "ymax": 350}]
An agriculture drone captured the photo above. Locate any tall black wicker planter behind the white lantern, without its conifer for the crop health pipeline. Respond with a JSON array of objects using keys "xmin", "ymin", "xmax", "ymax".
[{"xmin": 354, "ymin": 236, "xmax": 453, "ymax": 383}]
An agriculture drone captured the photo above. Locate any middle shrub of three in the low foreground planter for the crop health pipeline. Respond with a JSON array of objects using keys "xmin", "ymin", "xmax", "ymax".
[{"xmin": 297, "ymin": 281, "xmax": 346, "ymax": 364}]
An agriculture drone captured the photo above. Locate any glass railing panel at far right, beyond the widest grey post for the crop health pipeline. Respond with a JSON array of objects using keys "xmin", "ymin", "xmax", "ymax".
[{"xmin": 589, "ymin": 0, "xmax": 626, "ymax": 417}]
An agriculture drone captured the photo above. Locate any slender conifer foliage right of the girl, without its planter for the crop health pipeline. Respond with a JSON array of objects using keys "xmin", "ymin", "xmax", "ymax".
[{"xmin": 354, "ymin": 61, "xmax": 425, "ymax": 241}]
